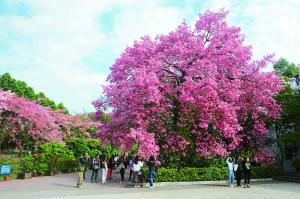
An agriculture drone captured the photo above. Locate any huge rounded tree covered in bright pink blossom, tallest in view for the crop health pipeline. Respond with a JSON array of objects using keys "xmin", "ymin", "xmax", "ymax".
[{"xmin": 94, "ymin": 10, "xmax": 282, "ymax": 158}]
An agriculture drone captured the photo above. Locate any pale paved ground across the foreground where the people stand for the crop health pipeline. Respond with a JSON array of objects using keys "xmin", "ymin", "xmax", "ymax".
[{"xmin": 0, "ymin": 170, "xmax": 300, "ymax": 199}]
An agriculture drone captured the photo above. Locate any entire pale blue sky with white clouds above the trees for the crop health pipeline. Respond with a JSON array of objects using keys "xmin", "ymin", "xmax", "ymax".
[{"xmin": 0, "ymin": 0, "xmax": 300, "ymax": 113}]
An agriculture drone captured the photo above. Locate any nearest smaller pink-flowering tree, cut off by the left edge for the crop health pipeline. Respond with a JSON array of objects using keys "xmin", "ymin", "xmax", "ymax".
[{"xmin": 0, "ymin": 90, "xmax": 62, "ymax": 148}]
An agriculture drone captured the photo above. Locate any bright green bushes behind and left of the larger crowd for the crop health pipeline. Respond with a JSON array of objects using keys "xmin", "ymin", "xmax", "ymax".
[{"xmin": 22, "ymin": 138, "xmax": 118, "ymax": 175}]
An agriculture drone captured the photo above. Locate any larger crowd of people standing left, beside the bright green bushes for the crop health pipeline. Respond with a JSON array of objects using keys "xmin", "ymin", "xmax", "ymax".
[{"xmin": 76, "ymin": 153, "xmax": 157, "ymax": 188}]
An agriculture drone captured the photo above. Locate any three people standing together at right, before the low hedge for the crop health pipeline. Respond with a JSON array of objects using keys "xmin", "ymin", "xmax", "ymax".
[{"xmin": 226, "ymin": 157, "xmax": 251, "ymax": 188}]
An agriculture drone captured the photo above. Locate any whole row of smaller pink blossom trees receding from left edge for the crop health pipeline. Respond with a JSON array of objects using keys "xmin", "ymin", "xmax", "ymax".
[{"xmin": 0, "ymin": 89, "xmax": 100, "ymax": 149}]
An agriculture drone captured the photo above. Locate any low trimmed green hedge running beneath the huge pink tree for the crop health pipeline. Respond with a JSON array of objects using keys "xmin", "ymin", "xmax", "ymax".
[{"xmin": 142, "ymin": 167, "xmax": 281, "ymax": 182}]
